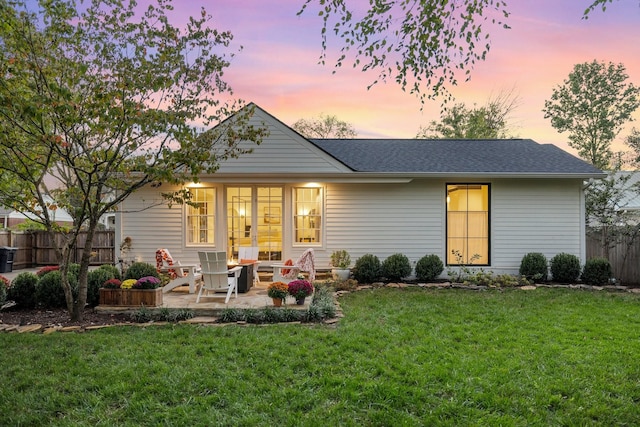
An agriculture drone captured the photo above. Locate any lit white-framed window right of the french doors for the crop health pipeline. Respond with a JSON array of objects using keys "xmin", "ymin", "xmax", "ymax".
[{"xmin": 293, "ymin": 187, "xmax": 323, "ymax": 245}]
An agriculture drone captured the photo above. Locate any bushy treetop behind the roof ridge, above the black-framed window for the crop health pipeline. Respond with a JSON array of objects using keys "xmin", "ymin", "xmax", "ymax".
[{"xmin": 416, "ymin": 92, "xmax": 519, "ymax": 139}]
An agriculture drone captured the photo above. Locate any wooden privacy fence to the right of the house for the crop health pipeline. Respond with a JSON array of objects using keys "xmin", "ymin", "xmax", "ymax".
[{"xmin": 587, "ymin": 234, "xmax": 640, "ymax": 286}]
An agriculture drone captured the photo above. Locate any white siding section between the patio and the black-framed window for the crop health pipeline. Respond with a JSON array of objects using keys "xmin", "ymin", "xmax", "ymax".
[{"xmin": 326, "ymin": 181, "xmax": 443, "ymax": 262}]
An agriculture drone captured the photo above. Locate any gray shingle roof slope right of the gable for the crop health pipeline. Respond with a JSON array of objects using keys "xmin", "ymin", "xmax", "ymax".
[{"xmin": 310, "ymin": 139, "xmax": 602, "ymax": 175}]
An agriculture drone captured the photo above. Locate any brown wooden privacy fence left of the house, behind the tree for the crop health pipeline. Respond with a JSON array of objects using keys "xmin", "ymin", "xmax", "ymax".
[{"xmin": 0, "ymin": 230, "xmax": 115, "ymax": 269}]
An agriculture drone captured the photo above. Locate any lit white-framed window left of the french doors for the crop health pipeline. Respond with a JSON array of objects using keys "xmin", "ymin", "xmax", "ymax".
[{"xmin": 187, "ymin": 188, "xmax": 216, "ymax": 246}]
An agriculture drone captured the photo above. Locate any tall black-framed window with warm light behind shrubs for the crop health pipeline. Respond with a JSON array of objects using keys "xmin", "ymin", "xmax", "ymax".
[{"xmin": 447, "ymin": 184, "xmax": 489, "ymax": 265}]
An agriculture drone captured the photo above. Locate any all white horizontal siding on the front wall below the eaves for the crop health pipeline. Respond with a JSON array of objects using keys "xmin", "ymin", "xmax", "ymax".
[{"xmin": 117, "ymin": 179, "xmax": 584, "ymax": 274}]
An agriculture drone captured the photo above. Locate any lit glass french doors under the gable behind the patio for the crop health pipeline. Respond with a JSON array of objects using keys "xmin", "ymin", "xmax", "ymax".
[{"xmin": 226, "ymin": 186, "xmax": 283, "ymax": 261}]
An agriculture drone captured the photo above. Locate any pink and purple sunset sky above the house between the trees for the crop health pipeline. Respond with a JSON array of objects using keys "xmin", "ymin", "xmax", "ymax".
[{"xmin": 180, "ymin": 0, "xmax": 640, "ymax": 153}]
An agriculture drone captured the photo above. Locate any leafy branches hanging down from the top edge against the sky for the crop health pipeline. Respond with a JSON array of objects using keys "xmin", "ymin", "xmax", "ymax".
[{"xmin": 298, "ymin": 0, "xmax": 509, "ymax": 101}]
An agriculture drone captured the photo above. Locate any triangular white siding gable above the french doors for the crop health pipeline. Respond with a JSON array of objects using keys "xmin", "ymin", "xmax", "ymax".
[{"xmin": 214, "ymin": 109, "xmax": 348, "ymax": 173}]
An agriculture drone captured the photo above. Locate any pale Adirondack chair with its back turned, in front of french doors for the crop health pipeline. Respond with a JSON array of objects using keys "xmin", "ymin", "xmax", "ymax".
[{"xmin": 196, "ymin": 252, "xmax": 242, "ymax": 304}]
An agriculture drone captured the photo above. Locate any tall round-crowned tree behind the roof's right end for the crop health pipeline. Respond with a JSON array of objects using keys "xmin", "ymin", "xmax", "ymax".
[{"xmin": 543, "ymin": 60, "xmax": 640, "ymax": 169}]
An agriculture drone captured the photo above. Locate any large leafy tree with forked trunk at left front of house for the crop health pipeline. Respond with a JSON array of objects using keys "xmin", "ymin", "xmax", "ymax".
[{"xmin": 0, "ymin": 0, "xmax": 264, "ymax": 318}]
